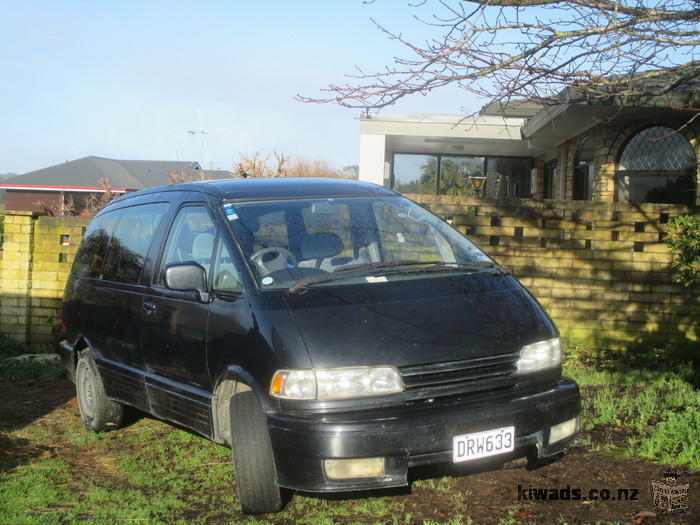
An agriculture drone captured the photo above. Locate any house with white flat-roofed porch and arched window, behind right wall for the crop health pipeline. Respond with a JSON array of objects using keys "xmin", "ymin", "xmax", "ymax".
[{"xmin": 360, "ymin": 83, "xmax": 700, "ymax": 205}]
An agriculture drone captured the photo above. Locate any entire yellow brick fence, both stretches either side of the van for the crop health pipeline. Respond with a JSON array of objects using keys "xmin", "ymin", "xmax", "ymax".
[{"xmin": 0, "ymin": 195, "xmax": 700, "ymax": 351}]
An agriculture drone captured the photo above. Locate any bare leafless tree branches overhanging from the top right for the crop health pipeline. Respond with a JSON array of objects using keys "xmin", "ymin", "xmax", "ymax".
[{"xmin": 298, "ymin": 0, "xmax": 700, "ymax": 112}]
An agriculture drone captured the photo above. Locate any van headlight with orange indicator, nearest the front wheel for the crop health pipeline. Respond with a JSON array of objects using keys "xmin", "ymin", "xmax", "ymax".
[{"xmin": 270, "ymin": 366, "xmax": 404, "ymax": 400}]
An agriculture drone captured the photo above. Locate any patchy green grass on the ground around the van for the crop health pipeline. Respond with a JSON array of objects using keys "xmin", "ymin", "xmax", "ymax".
[{"xmin": 0, "ymin": 342, "xmax": 700, "ymax": 525}]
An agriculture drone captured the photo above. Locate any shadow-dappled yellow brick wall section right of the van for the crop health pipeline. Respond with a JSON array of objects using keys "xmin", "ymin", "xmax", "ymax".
[{"xmin": 407, "ymin": 195, "xmax": 700, "ymax": 349}]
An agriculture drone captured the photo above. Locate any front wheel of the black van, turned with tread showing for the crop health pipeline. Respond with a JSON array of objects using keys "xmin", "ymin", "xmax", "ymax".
[{"xmin": 230, "ymin": 392, "xmax": 282, "ymax": 514}]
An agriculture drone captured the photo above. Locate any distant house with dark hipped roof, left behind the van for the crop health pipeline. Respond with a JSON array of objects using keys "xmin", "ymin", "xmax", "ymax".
[{"xmin": 0, "ymin": 156, "xmax": 233, "ymax": 212}]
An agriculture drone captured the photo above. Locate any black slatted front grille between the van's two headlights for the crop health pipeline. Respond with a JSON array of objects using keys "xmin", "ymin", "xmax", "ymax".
[{"xmin": 399, "ymin": 352, "xmax": 519, "ymax": 391}]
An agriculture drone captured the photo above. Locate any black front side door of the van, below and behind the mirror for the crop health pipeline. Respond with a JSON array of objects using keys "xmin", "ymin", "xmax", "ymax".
[{"xmin": 141, "ymin": 203, "xmax": 217, "ymax": 435}]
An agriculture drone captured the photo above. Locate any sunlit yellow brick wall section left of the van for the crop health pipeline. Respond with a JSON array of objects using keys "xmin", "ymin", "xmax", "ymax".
[{"xmin": 0, "ymin": 212, "xmax": 89, "ymax": 351}]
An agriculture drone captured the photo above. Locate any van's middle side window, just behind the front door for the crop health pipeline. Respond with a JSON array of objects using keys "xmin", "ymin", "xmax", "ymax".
[{"xmin": 102, "ymin": 202, "xmax": 169, "ymax": 283}]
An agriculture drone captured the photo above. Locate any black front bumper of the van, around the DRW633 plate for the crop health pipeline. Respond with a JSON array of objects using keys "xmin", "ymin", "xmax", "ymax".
[{"xmin": 268, "ymin": 378, "xmax": 581, "ymax": 492}]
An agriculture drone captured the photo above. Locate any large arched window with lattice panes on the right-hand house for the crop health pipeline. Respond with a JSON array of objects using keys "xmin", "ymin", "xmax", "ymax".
[{"xmin": 617, "ymin": 126, "xmax": 696, "ymax": 205}]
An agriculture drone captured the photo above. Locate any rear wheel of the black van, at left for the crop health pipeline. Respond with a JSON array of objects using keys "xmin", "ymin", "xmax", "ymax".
[{"xmin": 75, "ymin": 350, "xmax": 124, "ymax": 432}]
